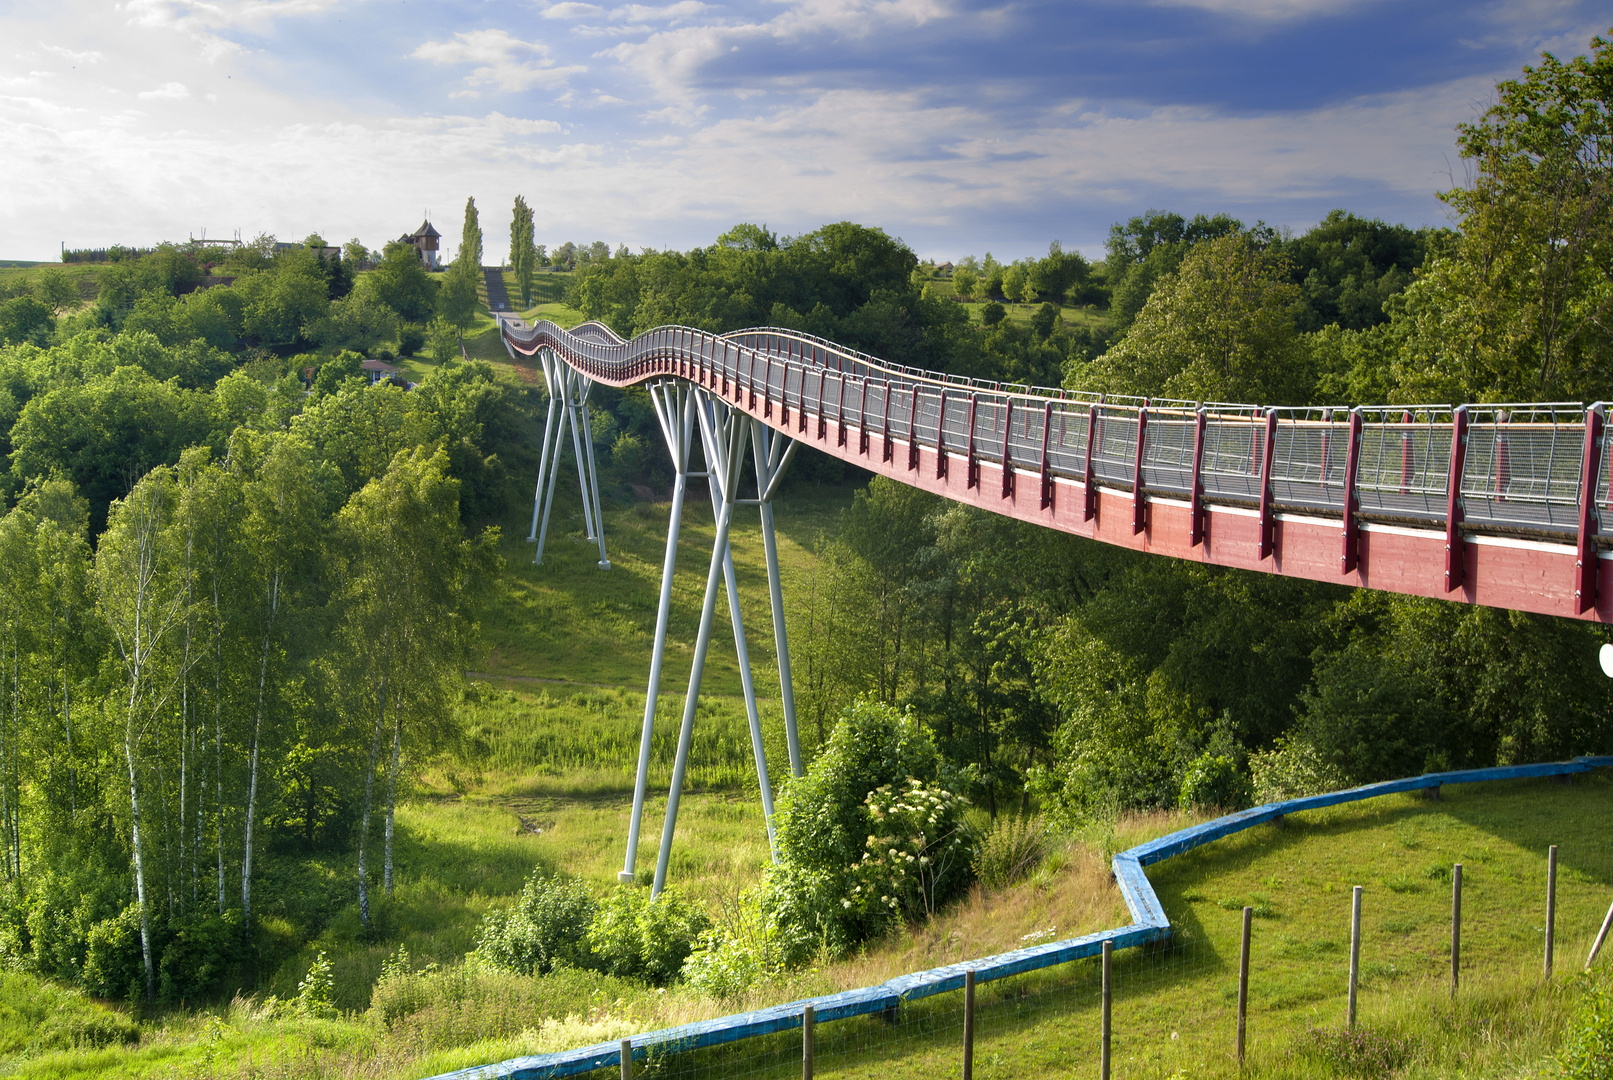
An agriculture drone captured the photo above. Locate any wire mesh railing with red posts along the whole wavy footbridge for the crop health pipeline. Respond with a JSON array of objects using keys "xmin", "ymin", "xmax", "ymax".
[{"xmin": 505, "ymin": 317, "xmax": 1613, "ymax": 537}]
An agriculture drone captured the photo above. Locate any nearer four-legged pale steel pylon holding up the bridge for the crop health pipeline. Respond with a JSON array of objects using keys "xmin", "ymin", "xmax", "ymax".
[{"xmin": 618, "ymin": 379, "xmax": 803, "ymax": 896}]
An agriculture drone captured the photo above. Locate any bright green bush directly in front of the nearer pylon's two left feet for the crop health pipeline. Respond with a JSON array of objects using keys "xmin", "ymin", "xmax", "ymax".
[{"xmin": 587, "ymin": 885, "xmax": 711, "ymax": 987}]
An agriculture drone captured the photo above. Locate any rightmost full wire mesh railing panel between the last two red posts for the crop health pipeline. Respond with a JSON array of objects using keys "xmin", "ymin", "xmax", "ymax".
[{"xmin": 1461, "ymin": 406, "xmax": 1586, "ymax": 532}]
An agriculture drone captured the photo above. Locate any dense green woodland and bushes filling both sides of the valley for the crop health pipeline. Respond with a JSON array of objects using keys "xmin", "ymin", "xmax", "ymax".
[{"xmin": 0, "ymin": 33, "xmax": 1613, "ymax": 1018}]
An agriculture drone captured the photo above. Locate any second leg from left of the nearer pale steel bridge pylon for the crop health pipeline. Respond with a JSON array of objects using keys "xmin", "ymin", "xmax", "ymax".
[{"xmin": 650, "ymin": 390, "xmax": 750, "ymax": 898}]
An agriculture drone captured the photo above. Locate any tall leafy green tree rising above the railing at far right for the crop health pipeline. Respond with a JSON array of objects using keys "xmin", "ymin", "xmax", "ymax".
[{"xmin": 1400, "ymin": 37, "xmax": 1613, "ymax": 401}]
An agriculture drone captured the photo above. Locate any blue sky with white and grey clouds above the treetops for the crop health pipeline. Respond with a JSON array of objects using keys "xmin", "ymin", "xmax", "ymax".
[{"xmin": 0, "ymin": 0, "xmax": 1613, "ymax": 264}]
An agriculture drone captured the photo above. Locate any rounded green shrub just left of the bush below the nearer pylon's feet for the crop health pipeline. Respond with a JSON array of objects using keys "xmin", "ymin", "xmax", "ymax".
[{"xmin": 476, "ymin": 870, "xmax": 598, "ymax": 975}]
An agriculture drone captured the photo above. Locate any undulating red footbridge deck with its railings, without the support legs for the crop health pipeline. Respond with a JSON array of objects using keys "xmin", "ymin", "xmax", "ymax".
[{"xmin": 502, "ymin": 321, "xmax": 1613, "ymax": 621}]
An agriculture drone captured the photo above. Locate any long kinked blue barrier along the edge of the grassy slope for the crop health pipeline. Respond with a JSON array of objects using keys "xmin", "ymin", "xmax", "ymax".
[{"xmin": 432, "ymin": 758, "xmax": 1613, "ymax": 1080}]
